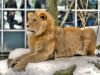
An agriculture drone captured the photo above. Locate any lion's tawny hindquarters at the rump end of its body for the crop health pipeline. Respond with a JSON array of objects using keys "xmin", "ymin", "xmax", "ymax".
[{"xmin": 83, "ymin": 29, "xmax": 96, "ymax": 55}]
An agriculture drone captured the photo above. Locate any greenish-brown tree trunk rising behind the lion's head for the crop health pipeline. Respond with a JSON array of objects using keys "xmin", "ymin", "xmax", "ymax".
[{"xmin": 46, "ymin": 0, "xmax": 58, "ymax": 25}]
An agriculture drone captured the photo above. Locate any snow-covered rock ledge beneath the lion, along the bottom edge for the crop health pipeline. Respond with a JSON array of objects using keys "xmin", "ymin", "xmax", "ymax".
[{"xmin": 0, "ymin": 56, "xmax": 100, "ymax": 75}]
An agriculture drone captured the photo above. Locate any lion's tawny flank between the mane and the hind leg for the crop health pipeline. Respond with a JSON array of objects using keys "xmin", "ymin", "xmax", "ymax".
[{"xmin": 55, "ymin": 27, "xmax": 82, "ymax": 57}]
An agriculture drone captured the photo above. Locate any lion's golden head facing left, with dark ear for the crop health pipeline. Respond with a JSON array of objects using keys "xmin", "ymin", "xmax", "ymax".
[{"xmin": 27, "ymin": 10, "xmax": 54, "ymax": 36}]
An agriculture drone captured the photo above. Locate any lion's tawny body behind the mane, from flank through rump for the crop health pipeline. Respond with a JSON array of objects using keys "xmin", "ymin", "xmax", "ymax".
[{"xmin": 55, "ymin": 27, "xmax": 96, "ymax": 57}]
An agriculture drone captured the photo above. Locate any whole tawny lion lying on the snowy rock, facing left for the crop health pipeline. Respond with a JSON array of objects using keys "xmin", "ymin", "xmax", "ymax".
[{"xmin": 10, "ymin": 10, "xmax": 96, "ymax": 70}]
